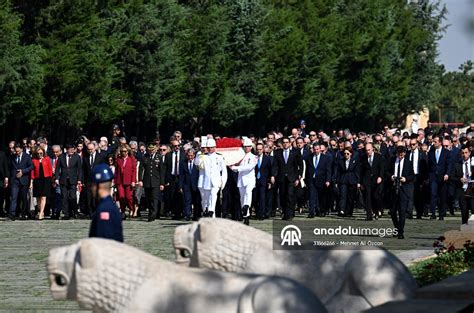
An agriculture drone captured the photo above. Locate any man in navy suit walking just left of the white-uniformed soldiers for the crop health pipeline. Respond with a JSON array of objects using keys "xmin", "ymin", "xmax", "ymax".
[{"xmin": 179, "ymin": 149, "xmax": 201, "ymax": 221}]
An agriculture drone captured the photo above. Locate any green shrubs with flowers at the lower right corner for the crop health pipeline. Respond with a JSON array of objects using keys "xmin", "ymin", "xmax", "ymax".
[{"xmin": 410, "ymin": 236, "xmax": 474, "ymax": 287}]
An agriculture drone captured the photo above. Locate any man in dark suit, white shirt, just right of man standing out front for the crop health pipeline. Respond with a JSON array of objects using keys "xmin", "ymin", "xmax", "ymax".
[{"xmin": 407, "ymin": 138, "xmax": 429, "ymax": 219}]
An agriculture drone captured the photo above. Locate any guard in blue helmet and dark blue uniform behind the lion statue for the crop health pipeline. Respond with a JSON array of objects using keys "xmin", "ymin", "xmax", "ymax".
[{"xmin": 89, "ymin": 164, "xmax": 123, "ymax": 242}]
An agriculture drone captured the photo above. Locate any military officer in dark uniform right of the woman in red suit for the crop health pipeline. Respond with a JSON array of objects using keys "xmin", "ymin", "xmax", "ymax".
[{"xmin": 138, "ymin": 143, "xmax": 165, "ymax": 222}]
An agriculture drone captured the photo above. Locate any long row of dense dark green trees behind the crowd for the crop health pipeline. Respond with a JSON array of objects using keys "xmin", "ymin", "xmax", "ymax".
[{"xmin": 0, "ymin": 0, "xmax": 466, "ymax": 140}]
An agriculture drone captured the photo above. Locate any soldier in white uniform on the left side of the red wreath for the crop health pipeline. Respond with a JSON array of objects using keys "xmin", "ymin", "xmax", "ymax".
[{"xmin": 195, "ymin": 138, "xmax": 227, "ymax": 218}]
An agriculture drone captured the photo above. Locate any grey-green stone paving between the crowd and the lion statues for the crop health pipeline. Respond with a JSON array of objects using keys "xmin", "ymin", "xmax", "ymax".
[{"xmin": 0, "ymin": 211, "xmax": 460, "ymax": 312}]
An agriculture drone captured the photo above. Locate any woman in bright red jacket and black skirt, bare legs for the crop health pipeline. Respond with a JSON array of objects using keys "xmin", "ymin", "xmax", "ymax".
[{"xmin": 30, "ymin": 147, "xmax": 53, "ymax": 220}]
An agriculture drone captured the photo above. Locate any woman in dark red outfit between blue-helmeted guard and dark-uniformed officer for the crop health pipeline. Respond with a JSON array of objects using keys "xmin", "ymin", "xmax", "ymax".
[{"xmin": 115, "ymin": 144, "xmax": 137, "ymax": 219}]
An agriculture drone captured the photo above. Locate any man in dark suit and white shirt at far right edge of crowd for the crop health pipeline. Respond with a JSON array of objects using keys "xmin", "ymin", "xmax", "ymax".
[{"xmin": 449, "ymin": 146, "xmax": 474, "ymax": 224}]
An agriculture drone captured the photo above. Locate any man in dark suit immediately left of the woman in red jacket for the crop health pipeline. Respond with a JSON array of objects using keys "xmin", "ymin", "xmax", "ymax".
[{"xmin": 7, "ymin": 144, "xmax": 33, "ymax": 221}]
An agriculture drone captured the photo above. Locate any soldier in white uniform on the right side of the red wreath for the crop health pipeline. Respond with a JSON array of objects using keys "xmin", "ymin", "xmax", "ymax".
[{"xmin": 231, "ymin": 138, "xmax": 258, "ymax": 225}]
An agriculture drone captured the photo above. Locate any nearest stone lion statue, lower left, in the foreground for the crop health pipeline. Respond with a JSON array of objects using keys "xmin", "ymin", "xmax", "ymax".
[{"xmin": 47, "ymin": 238, "xmax": 327, "ymax": 313}]
